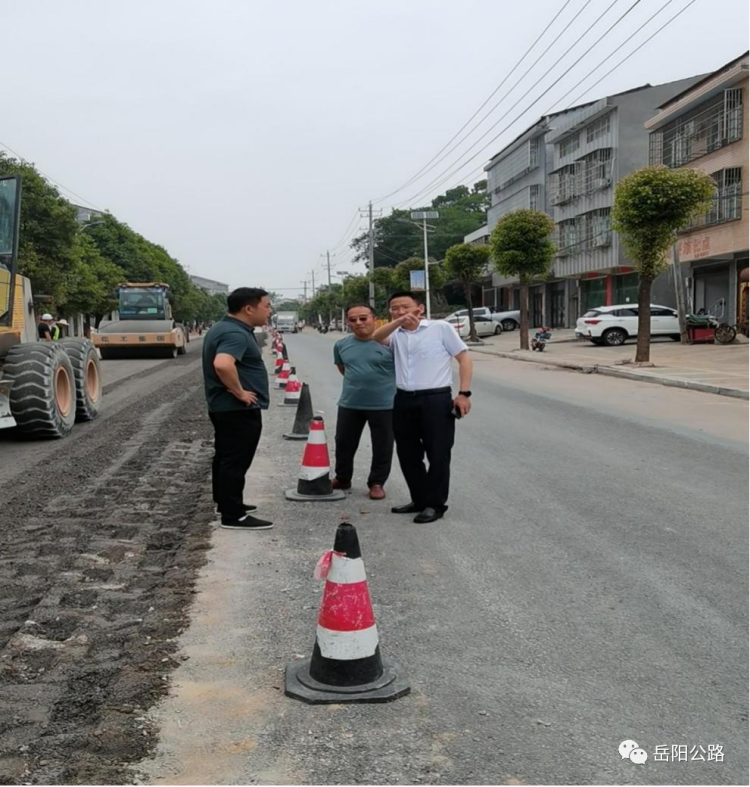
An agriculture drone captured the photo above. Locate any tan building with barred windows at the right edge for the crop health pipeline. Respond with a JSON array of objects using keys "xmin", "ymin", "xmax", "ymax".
[{"xmin": 646, "ymin": 52, "xmax": 750, "ymax": 323}]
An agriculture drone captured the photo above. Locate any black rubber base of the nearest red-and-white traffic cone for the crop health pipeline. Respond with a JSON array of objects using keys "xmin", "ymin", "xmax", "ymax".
[{"xmin": 284, "ymin": 659, "xmax": 411, "ymax": 705}]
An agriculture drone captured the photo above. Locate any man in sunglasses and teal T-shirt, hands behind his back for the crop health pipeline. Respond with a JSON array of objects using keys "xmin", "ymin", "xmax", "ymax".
[{"xmin": 333, "ymin": 305, "xmax": 396, "ymax": 500}]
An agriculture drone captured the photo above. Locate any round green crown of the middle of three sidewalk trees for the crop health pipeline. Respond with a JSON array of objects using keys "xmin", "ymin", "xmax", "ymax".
[{"xmin": 490, "ymin": 209, "xmax": 555, "ymax": 285}]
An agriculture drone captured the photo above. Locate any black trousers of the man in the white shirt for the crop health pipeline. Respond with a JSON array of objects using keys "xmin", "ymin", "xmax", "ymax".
[{"xmin": 393, "ymin": 391, "xmax": 456, "ymax": 511}]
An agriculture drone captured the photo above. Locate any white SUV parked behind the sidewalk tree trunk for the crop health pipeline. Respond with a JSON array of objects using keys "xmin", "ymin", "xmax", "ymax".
[{"xmin": 576, "ymin": 303, "xmax": 680, "ymax": 347}]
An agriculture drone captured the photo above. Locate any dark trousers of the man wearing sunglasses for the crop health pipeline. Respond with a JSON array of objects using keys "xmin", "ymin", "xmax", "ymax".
[{"xmin": 336, "ymin": 407, "xmax": 393, "ymax": 486}]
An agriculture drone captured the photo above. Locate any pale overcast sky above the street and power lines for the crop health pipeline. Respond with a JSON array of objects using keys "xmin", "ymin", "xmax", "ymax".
[{"xmin": 0, "ymin": 0, "xmax": 750, "ymax": 295}]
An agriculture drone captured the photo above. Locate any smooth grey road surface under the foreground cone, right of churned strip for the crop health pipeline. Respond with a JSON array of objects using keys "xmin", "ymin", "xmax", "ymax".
[{"xmin": 143, "ymin": 332, "xmax": 750, "ymax": 785}]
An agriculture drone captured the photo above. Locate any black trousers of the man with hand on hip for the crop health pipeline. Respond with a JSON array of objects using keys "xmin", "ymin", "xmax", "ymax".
[{"xmin": 209, "ymin": 409, "xmax": 263, "ymax": 520}]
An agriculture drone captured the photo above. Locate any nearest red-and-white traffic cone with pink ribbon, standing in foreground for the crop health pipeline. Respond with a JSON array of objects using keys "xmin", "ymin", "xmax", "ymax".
[{"xmin": 284, "ymin": 523, "xmax": 411, "ymax": 705}]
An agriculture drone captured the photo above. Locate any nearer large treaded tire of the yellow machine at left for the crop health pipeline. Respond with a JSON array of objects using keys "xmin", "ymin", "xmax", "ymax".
[{"xmin": 3, "ymin": 342, "xmax": 76, "ymax": 439}]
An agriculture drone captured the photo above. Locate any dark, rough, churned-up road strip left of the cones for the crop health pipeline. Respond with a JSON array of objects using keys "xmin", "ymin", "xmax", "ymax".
[{"xmin": 0, "ymin": 342, "xmax": 220, "ymax": 785}]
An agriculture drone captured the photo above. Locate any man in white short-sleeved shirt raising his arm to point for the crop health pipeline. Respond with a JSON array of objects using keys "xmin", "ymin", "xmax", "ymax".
[{"xmin": 375, "ymin": 292, "xmax": 473, "ymax": 522}]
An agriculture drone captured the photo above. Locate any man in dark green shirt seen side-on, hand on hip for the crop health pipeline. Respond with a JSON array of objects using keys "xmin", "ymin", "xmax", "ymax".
[{"xmin": 203, "ymin": 287, "xmax": 273, "ymax": 530}]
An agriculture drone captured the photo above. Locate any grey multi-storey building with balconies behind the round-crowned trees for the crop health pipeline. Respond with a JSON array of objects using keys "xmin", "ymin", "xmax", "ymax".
[{"xmin": 487, "ymin": 77, "xmax": 699, "ymax": 327}]
